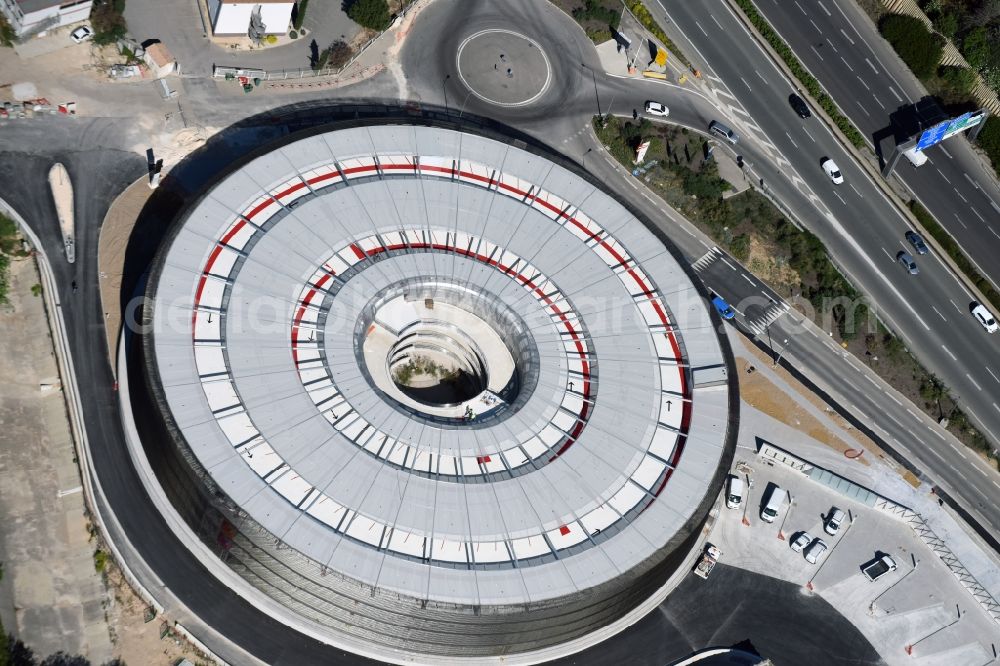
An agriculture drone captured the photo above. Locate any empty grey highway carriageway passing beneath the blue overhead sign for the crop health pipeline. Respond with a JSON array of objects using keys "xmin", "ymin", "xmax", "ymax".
[{"xmin": 757, "ymin": 0, "xmax": 1000, "ymax": 294}]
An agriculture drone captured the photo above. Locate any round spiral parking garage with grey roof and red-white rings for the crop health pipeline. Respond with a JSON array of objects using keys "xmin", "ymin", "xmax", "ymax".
[{"xmin": 139, "ymin": 125, "xmax": 735, "ymax": 659}]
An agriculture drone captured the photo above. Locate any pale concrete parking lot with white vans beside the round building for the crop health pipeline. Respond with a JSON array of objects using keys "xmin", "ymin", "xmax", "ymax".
[{"xmin": 709, "ymin": 449, "xmax": 1000, "ymax": 666}]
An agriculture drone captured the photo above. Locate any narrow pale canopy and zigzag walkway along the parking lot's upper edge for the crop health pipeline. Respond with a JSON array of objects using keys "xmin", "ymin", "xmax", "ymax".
[{"xmin": 757, "ymin": 440, "xmax": 1000, "ymax": 623}]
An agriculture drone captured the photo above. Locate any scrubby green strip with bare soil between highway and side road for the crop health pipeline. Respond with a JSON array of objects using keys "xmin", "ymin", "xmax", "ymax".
[{"xmin": 593, "ymin": 117, "xmax": 997, "ymax": 465}]
